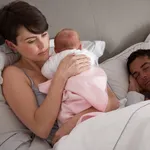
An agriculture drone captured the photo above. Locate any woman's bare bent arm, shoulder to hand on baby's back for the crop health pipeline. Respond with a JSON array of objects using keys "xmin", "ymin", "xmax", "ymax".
[{"xmin": 3, "ymin": 55, "xmax": 89, "ymax": 138}]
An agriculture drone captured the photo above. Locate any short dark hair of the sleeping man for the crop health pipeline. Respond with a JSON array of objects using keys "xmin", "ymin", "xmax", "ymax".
[{"xmin": 127, "ymin": 49, "xmax": 150, "ymax": 74}]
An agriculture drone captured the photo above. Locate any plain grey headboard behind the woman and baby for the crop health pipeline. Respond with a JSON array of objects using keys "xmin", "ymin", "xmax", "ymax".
[{"xmin": 0, "ymin": 0, "xmax": 150, "ymax": 60}]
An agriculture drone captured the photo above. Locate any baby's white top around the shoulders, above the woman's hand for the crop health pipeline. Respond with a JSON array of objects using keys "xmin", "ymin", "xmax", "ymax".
[{"xmin": 41, "ymin": 49, "xmax": 98, "ymax": 79}]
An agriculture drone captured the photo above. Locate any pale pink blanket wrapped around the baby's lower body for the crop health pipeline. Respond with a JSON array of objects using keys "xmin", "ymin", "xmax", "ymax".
[{"xmin": 39, "ymin": 67, "xmax": 108, "ymax": 124}]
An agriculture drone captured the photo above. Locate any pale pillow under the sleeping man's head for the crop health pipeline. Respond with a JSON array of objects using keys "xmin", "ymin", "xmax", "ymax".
[{"xmin": 100, "ymin": 42, "xmax": 150, "ymax": 99}]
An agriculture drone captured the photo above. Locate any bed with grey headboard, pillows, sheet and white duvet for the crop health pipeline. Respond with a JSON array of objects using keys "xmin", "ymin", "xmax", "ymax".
[{"xmin": 0, "ymin": 0, "xmax": 150, "ymax": 150}]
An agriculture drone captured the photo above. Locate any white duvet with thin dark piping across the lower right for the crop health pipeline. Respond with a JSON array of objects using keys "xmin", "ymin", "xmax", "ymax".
[{"xmin": 53, "ymin": 101, "xmax": 150, "ymax": 150}]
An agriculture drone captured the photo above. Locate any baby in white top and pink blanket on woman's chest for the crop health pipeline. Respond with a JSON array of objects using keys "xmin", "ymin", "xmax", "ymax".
[{"xmin": 39, "ymin": 29, "xmax": 119, "ymax": 125}]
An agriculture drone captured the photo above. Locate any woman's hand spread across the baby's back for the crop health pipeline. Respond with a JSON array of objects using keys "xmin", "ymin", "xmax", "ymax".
[{"xmin": 57, "ymin": 54, "xmax": 90, "ymax": 79}]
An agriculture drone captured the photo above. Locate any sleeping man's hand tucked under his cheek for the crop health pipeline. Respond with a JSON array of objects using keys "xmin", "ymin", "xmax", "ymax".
[{"xmin": 128, "ymin": 75, "xmax": 141, "ymax": 93}]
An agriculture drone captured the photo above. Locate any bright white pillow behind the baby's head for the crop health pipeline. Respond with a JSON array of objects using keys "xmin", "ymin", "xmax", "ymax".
[{"xmin": 50, "ymin": 39, "xmax": 106, "ymax": 57}]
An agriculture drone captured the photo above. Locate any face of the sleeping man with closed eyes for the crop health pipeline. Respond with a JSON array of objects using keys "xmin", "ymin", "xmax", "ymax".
[{"xmin": 130, "ymin": 56, "xmax": 150, "ymax": 92}]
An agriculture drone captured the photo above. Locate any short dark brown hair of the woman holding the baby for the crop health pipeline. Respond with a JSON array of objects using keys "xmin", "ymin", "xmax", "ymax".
[{"xmin": 0, "ymin": 0, "xmax": 48, "ymax": 44}]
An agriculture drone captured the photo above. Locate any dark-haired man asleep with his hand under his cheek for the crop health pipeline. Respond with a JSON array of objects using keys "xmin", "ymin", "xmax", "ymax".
[{"xmin": 126, "ymin": 49, "xmax": 150, "ymax": 106}]
